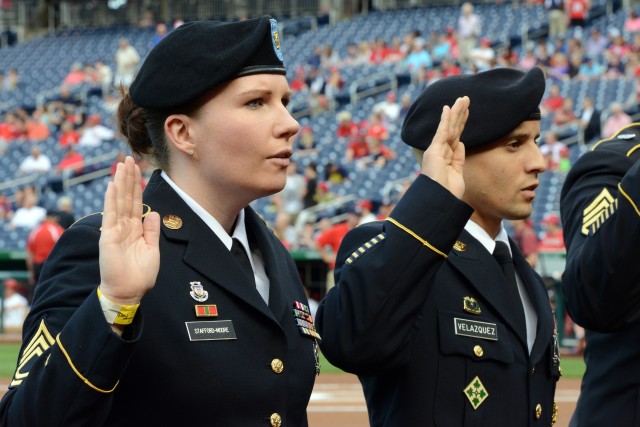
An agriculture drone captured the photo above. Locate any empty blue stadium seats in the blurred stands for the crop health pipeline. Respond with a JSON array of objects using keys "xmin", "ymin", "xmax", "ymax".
[{"xmin": 0, "ymin": 0, "xmax": 635, "ymax": 248}]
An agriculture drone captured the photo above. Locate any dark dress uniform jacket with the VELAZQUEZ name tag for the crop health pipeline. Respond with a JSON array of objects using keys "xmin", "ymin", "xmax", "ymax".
[{"xmin": 317, "ymin": 176, "xmax": 559, "ymax": 427}]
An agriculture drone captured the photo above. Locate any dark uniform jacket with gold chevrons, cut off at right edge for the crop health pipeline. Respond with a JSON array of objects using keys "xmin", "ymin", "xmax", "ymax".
[{"xmin": 560, "ymin": 123, "xmax": 640, "ymax": 427}]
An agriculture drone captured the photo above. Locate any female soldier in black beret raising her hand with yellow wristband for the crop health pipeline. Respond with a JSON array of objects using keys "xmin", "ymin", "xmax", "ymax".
[{"xmin": 0, "ymin": 17, "xmax": 317, "ymax": 426}]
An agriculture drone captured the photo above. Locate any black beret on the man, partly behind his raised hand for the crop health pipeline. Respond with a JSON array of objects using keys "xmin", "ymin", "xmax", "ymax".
[{"xmin": 401, "ymin": 67, "xmax": 545, "ymax": 150}]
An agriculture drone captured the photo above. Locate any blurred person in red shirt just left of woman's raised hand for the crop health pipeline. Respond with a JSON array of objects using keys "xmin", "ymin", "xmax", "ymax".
[{"xmin": 26, "ymin": 210, "xmax": 64, "ymax": 304}]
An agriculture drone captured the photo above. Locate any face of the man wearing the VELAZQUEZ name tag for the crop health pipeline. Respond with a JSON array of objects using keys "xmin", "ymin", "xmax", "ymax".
[{"xmin": 463, "ymin": 120, "xmax": 546, "ymax": 235}]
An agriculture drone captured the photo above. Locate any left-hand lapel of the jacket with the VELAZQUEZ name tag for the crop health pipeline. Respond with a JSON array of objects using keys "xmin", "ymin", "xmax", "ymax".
[{"xmin": 447, "ymin": 231, "xmax": 527, "ymax": 348}]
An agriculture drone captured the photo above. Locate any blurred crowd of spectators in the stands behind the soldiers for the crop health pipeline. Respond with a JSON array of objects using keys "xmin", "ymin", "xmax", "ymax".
[{"xmin": 0, "ymin": 0, "xmax": 640, "ymax": 338}]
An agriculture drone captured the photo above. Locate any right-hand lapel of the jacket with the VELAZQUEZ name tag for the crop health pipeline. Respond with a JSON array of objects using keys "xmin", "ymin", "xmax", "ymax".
[{"xmin": 511, "ymin": 242, "xmax": 554, "ymax": 362}]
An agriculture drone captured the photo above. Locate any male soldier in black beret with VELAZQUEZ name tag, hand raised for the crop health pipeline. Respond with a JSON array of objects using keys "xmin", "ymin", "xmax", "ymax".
[{"xmin": 317, "ymin": 68, "xmax": 559, "ymax": 427}]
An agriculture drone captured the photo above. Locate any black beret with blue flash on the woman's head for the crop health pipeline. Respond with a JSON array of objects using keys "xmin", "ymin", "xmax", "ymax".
[{"xmin": 129, "ymin": 16, "xmax": 286, "ymax": 110}]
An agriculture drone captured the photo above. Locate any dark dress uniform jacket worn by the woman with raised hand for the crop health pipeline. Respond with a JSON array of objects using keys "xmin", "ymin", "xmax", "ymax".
[{"xmin": 0, "ymin": 172, "xmax": 315, "ymax": 427}]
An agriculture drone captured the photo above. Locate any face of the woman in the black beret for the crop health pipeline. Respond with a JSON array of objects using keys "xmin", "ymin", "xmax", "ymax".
[{"xmin": 190, "ymin": 74, "xmax": 300, "ymax": 202}]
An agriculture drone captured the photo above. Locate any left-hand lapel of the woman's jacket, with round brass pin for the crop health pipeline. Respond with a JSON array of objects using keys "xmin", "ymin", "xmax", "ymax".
[{"xmin": 144, "ymin": 172, "xmax": 275, "ymax": 320}]
